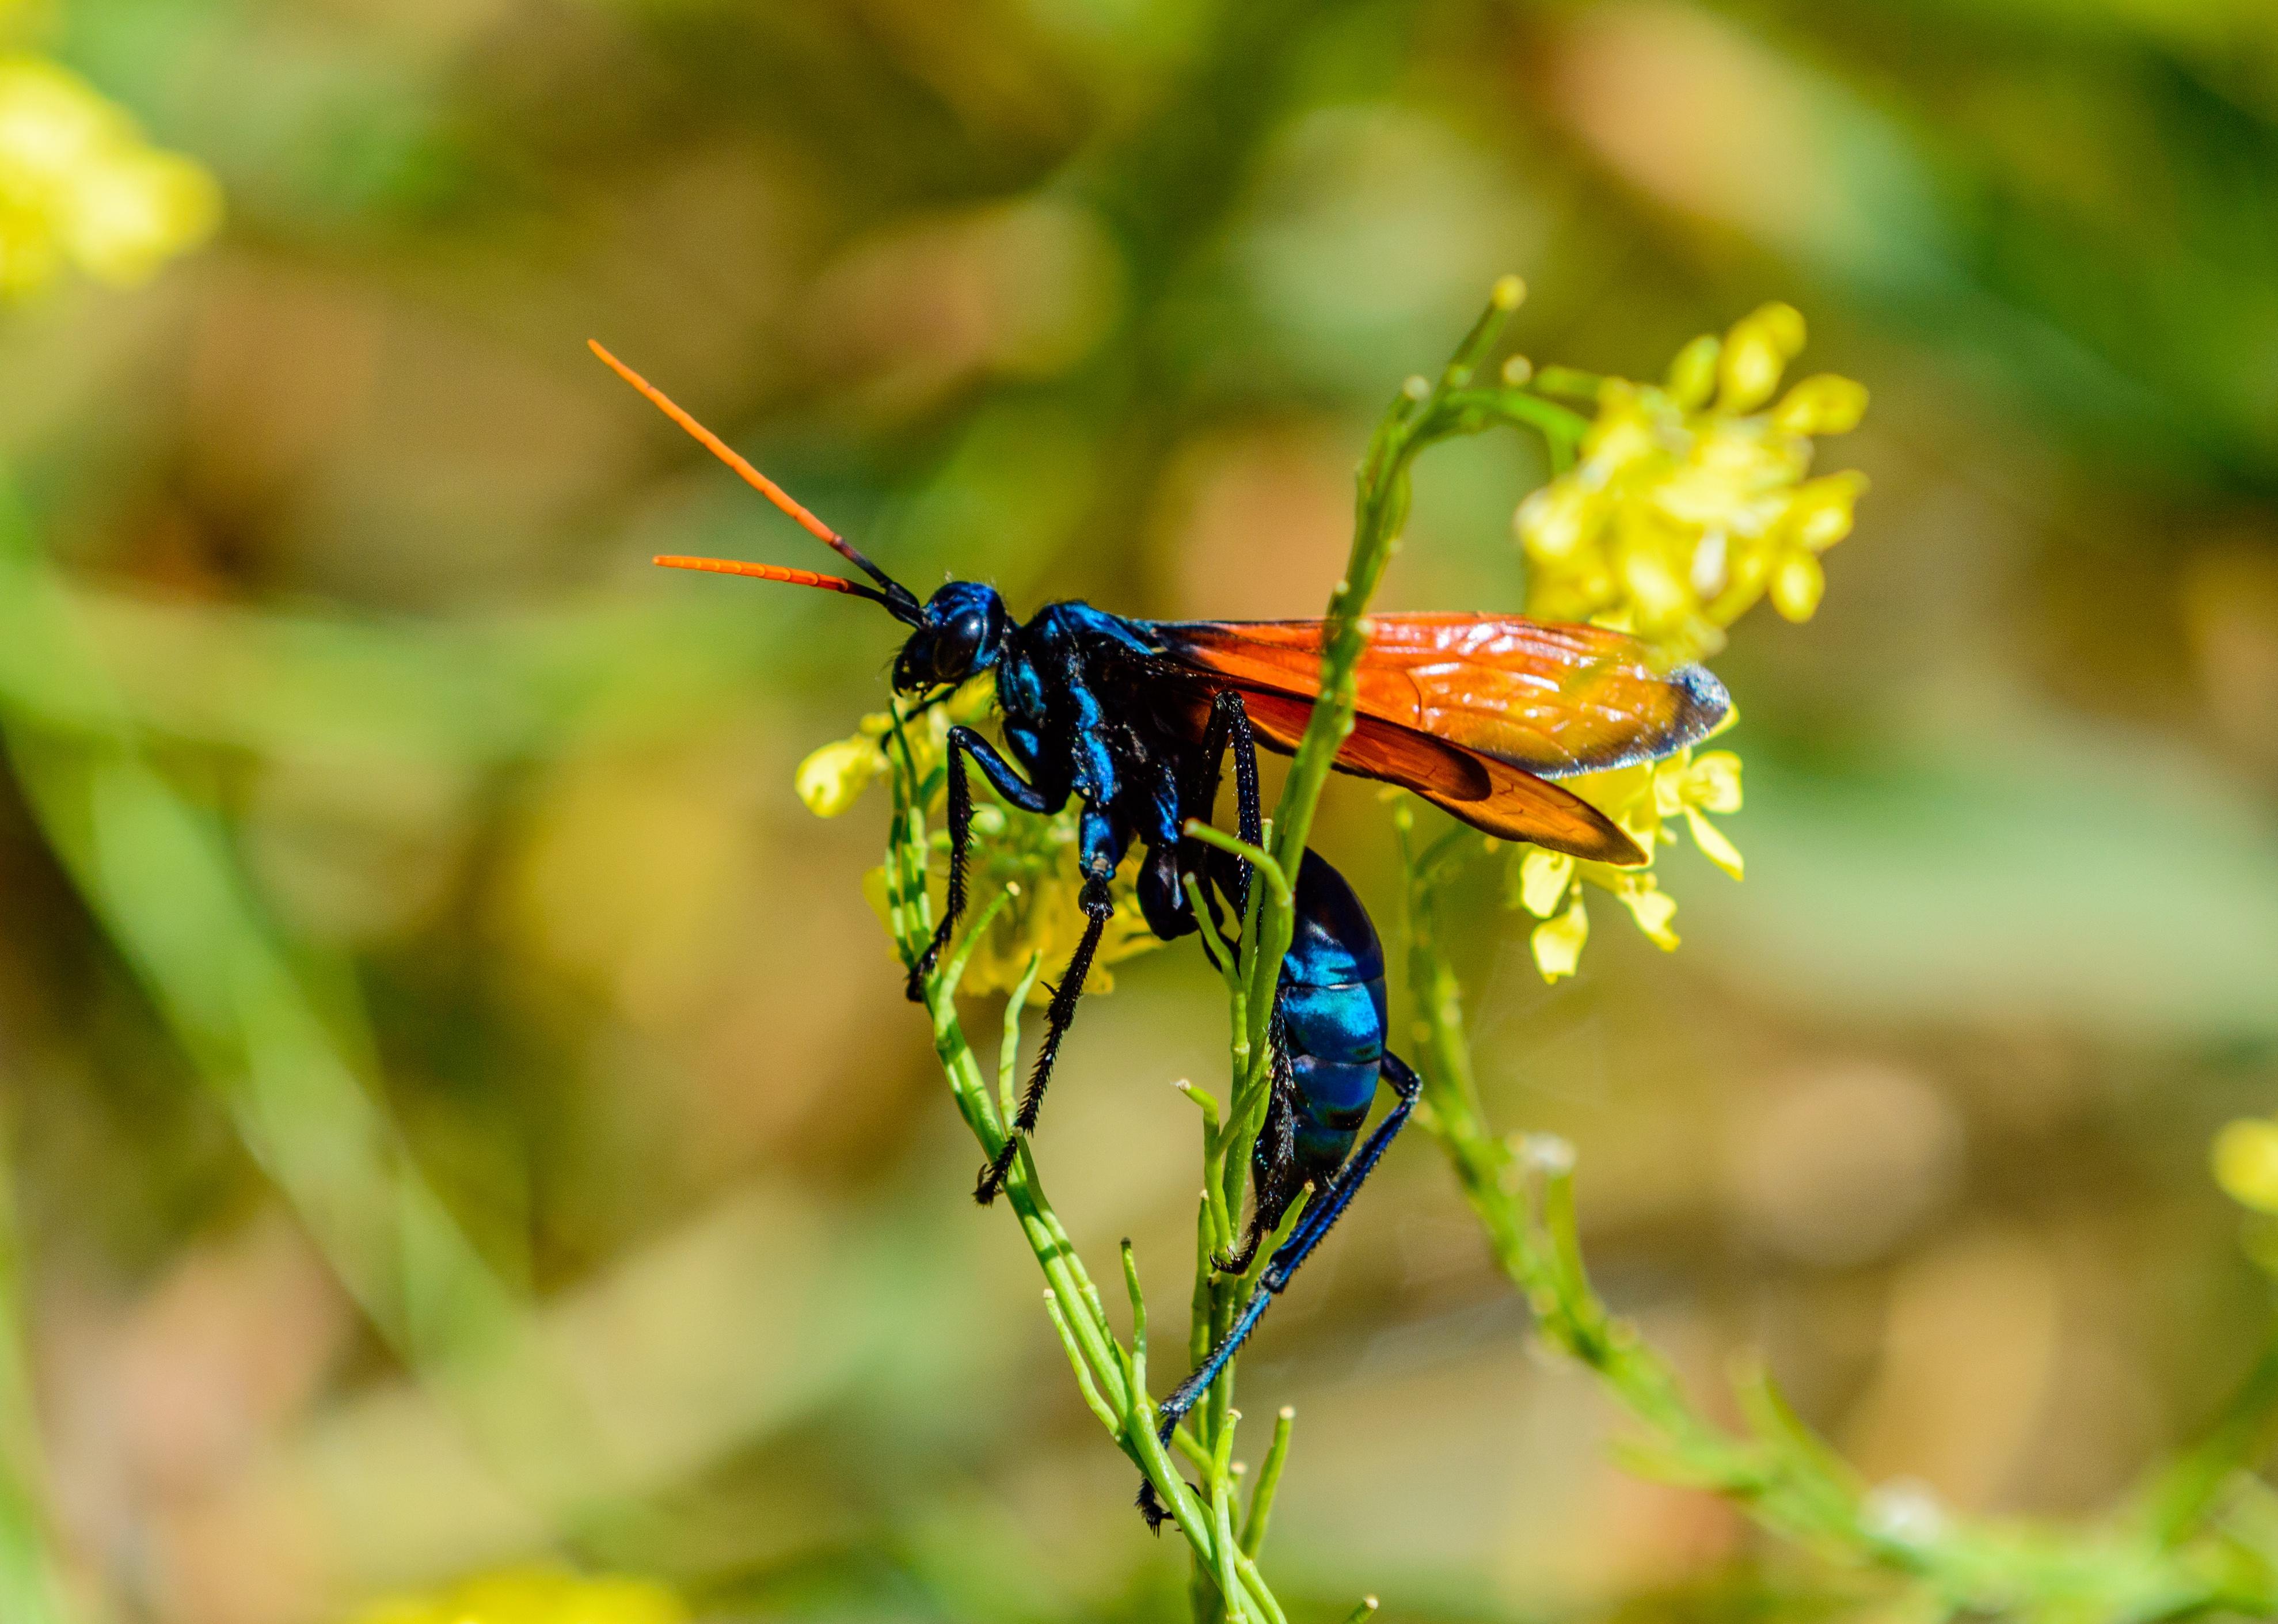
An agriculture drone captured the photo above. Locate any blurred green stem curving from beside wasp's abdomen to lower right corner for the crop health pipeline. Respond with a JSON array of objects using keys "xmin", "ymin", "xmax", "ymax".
[{"xmin": 1394, "ymin": 804, "xmax": 2278, "ymax": 1622}]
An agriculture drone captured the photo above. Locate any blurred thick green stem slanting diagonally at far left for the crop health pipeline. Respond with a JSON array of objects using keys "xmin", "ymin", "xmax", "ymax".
[{"xmin": 0, "ymin": 492, "xmax": 651, "ymax": 1540}]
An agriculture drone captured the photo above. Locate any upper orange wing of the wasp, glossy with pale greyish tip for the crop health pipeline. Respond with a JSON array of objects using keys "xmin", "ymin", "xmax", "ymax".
[{"xmin": 1146, "ymin": 615, "xmax": 1731, "ymax": 779}]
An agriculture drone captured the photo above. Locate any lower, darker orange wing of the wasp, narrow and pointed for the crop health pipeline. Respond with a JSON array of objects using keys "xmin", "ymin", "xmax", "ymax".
[{"xmin": 1196, "ymin": 683, "xmax": 1645, "ymax": 865}]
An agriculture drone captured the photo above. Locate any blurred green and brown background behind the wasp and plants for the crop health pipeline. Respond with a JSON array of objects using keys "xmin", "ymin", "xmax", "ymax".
[{"xmin": 0, "ymin": 0, "xmax": 2278, "ymax": 1624}]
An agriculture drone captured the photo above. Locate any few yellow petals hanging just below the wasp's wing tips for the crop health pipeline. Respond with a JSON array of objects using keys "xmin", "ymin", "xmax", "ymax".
[{"xmin": 1506, "ymin": 733, "xmax": 1743, "ymax": 982}]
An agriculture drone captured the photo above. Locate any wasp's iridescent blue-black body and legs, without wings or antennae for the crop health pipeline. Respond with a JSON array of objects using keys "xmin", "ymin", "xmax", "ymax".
[{"xmin": 895, "ymin": 583, "xmax": 1421, "ymax": 1522}]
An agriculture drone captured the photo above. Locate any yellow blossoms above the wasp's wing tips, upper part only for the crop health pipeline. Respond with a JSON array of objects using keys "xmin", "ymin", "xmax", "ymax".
[{"xmin": 1517, "ymin": 305, "xmax": 1866, "ymax": 660}]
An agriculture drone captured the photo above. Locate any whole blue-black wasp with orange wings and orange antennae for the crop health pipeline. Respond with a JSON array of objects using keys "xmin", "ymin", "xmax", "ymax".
[{"xmin": 592, "ymin": 344, "xmax": 1729, "ymax": 1526}]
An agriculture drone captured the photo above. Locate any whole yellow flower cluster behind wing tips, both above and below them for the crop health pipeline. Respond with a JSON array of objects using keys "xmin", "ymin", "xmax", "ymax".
[{"xmin": 1506, "ymin": 305, "xmax": 1866, "ymax": 982}]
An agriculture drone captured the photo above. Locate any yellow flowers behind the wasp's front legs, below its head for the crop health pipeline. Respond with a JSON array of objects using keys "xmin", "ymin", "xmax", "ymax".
[{"xmin": 795, "ymin": 676, "xmax": 1162, "ymax": 1005}]
